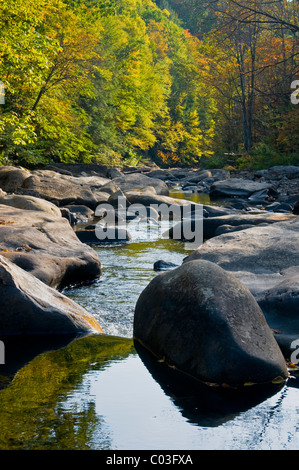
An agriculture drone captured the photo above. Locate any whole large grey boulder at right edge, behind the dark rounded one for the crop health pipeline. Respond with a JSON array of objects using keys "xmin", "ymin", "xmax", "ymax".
[{"xmin": 184, "ymin": 217, "xmax": 299, "ymax": 356}]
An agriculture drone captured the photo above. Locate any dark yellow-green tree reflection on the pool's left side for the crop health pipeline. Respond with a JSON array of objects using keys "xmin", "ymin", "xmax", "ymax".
[{"xmin": 0, "ymin": 335, "xmax": 135, "ymax": 450}]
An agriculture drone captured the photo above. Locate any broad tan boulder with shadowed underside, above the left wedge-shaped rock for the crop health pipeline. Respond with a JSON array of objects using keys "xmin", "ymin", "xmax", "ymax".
[{"xmin": 0, "ymin": 205, "xmax": 101, "ymax": 289}]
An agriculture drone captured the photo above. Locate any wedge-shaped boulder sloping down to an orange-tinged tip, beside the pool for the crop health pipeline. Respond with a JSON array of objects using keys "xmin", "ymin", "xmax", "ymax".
[{"xmin": 0, "ymin": 255, "xmax": 103, "ymax": 336}]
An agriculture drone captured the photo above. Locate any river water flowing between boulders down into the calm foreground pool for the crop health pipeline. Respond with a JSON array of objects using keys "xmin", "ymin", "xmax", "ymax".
[{"xmin": 0, "ymin": 192, "xmax": 299, "ymax": 450}]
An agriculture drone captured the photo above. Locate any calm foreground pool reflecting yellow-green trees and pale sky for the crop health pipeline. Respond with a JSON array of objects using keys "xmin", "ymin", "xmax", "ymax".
[{"xmin": 0, "ymin": 335, "xmax": 298, "ymax": 450}]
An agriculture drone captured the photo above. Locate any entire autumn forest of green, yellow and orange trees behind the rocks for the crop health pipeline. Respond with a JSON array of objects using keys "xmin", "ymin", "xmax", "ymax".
[{"xmin": 0, "ymin": 0, "xmax": 299, "ymax": 168}]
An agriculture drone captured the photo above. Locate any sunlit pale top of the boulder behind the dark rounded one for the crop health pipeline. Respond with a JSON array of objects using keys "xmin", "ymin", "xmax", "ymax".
[{"xmin": 185, "ymin": 218, "xmax": 299, "ymax": 295}]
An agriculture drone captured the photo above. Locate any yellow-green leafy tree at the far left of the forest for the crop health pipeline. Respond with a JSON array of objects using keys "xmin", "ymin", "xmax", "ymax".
[{"xmin": 0, "ymin": 0, "xmax": 102, "ymax": 163}]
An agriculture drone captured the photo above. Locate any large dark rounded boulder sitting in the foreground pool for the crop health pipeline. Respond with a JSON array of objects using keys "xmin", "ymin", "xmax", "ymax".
[{"xmin": 134, "ymin": 261, "xmax": 288, "ymax": 387}]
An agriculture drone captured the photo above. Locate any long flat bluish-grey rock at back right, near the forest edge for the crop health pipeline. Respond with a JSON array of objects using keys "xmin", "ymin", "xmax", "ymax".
[{"xmin": 210, "ymin": 178, "xmax": 277, "ymax": 198}]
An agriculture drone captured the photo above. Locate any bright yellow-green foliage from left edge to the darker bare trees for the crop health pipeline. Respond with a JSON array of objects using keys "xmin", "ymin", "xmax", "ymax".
[{"xmin": 0, "ymin": 0, "xmax": 218, "ymax": 165}]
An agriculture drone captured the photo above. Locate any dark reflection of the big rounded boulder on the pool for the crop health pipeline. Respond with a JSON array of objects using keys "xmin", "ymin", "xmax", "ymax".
[{"xmin": 134, "ymin": 341, "xmax": 283, "ymax": 427}]
